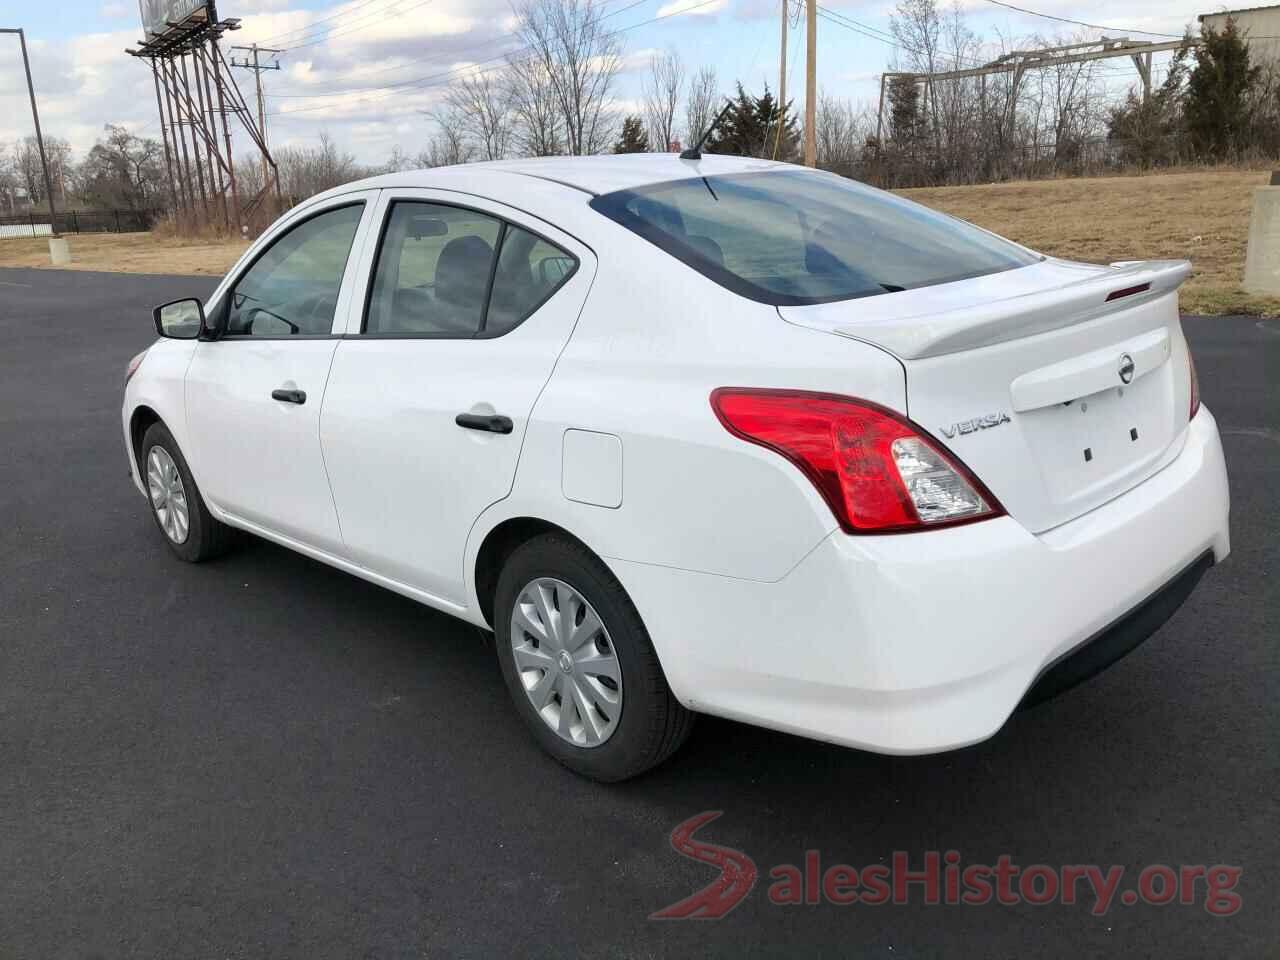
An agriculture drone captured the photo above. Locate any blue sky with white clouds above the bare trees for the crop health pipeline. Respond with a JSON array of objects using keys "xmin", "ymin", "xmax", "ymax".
[{"xmin": 0, "ymin": 0, "xmax": 1222, "ymax": 164}]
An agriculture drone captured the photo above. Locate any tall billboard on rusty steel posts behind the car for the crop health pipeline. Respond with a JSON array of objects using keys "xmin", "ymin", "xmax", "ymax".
[{"xmin": 125, "ymin": 0, "xmax": 280, "ymax": 233}]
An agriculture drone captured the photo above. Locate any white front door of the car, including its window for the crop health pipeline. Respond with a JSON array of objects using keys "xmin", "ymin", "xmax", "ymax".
[{"xmin": 187, "ymin": 191, "xmax": 378, "ymax": 553}]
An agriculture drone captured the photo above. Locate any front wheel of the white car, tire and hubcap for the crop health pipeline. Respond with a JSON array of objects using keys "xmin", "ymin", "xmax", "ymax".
[{"xmin": 138, "ymin": 422, "xmax": 233, "ymax": 563}]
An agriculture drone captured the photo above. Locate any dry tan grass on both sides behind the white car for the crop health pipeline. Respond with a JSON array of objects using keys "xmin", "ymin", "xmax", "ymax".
[{"xmin": 0, "ymin": 170, "xmax": 1280, "ymax": 315}]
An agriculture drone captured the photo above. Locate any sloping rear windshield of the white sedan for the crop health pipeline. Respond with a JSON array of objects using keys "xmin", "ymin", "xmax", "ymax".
[{"xmin": 591, "ymin": 170, "xmax": 1038, "ymax": 306}]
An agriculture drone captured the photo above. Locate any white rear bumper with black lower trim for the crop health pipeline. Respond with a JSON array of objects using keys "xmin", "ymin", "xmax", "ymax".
[{"xmin": 611, "ymin": 408, "xmax": 1230, "ymax": 754}]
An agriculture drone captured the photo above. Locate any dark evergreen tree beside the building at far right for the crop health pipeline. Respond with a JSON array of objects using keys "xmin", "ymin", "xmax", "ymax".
[{"xmin": 1183, "ymin": 17, "xmax": 1262, "ymax": 159}]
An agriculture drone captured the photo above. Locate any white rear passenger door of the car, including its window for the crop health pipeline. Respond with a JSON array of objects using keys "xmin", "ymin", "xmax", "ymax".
[{"xmin": 320, "ymin": 191, "xmax": 595, "ymax": 605}]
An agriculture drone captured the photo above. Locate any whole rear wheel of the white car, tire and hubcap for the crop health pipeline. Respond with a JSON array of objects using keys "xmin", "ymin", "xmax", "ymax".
[{"xmin": 494, "ymin": 534, "xmax": 694, "ymax": 781}]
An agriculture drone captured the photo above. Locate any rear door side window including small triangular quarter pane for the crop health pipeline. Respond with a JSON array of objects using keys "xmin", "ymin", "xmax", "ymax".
[{"xmin": 365, "ymin": 201, "xmax": 577, "ymax": 338}]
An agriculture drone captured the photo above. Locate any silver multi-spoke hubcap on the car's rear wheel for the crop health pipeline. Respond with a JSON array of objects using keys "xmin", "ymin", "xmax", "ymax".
[{"xmin": 511, "ymin": 577, "xmax": 622, "ymax": 746}]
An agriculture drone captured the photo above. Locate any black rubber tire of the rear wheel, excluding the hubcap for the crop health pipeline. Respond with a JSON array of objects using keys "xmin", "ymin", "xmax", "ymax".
[{"xmin": 494, "ymin": 534, "xmax": 695, "ymax": 782}]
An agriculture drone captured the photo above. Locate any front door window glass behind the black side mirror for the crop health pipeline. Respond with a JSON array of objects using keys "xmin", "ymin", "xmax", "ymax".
[{"xmin": 227, "ymin": 204, "xmax": 365, "ymax": 337}]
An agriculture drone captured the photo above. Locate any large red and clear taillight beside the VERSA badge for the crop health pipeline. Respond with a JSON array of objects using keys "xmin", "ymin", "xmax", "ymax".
[{"xmin": 712, "ymin": 387, "xmax": 1004, "ymax": 534}]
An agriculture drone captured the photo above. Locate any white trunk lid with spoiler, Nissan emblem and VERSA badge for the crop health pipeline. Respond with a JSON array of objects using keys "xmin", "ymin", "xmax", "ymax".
[{"xmin": 778, "ymin": 260, "xmax": 1190, "ymax": 532}]
